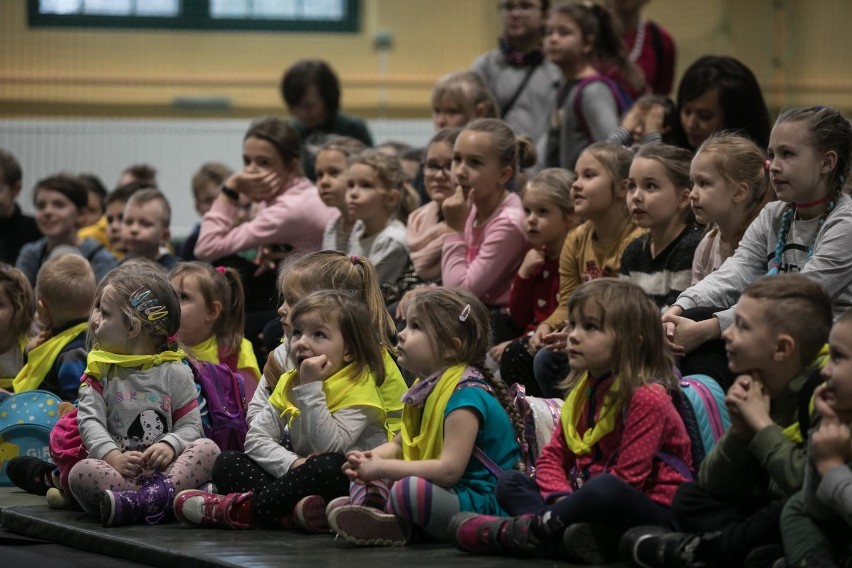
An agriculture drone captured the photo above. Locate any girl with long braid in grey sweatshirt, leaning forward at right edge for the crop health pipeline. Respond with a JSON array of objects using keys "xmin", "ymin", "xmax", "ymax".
[{"xmin": 663, "ymin": 107, "xmax": 852, "ymax": 360}]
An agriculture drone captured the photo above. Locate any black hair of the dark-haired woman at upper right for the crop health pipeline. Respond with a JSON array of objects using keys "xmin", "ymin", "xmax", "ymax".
[{"xmin": 675, "ymin": 55, "xmax": 770, "ymax": 149}]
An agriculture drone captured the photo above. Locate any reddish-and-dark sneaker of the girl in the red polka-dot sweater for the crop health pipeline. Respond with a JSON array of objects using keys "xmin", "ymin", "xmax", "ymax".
[{"xmin": 449, "ymin": 513, "xmax": 542, "ymax": 555}]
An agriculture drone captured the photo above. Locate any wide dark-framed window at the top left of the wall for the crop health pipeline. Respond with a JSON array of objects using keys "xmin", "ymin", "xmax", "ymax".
[{"xmin": 28, "ymin": 0, "xmax": 359, "ymax": 32}]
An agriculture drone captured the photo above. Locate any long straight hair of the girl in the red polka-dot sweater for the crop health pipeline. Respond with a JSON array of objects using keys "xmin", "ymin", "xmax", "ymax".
[{"xmin": 560, "ymin": 278, "xmax": 678, "ymax": 404}]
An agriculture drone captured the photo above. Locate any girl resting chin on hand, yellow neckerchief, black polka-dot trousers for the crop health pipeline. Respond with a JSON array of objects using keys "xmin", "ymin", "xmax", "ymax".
[{"xmin": 174, "ymin": 290, "xmax": 387, "ymax": 532}]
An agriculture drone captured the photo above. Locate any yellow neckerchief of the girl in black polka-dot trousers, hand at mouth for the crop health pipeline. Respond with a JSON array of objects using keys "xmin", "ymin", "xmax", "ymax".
[{"xmin": 269, "ymin": 363, "xmax": 384, "ymax": 424}]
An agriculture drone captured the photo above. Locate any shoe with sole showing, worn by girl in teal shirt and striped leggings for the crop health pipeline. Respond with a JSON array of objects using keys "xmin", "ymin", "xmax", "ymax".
[{"xmin": 328, "ymin": 505, "xmax": 411, "ymax": 546}]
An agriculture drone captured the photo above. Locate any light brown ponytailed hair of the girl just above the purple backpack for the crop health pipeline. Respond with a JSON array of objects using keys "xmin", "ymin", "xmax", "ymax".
[{"xmin": 169, "ymin": 261, "xmax": 245, "ymax": 357}]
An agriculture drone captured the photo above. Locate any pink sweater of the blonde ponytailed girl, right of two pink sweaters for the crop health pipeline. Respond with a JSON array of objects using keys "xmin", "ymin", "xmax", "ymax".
[{"xmin": 441, "ymin": 193, "xmax": 527, "ymax": 306}]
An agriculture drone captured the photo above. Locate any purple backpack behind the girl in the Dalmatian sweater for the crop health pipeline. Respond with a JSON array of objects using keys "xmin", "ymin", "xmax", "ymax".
[{"xmin": 190, "ymin": 361, "xmax": 248, "ymax": 452}]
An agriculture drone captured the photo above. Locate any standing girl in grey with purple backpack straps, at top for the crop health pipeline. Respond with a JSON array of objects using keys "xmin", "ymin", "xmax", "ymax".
[{"xmin": 544, "ymin": 3, "xmax": 625, "ymax": 170}]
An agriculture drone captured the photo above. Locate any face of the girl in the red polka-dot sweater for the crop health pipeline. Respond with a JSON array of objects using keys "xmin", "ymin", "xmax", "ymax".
[{"xmin": 568, "ymin": 306, "xmax": 615, "ymax": 377}]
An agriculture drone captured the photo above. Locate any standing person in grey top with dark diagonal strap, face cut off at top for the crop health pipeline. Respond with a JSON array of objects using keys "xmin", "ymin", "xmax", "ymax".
[{"xmin": 472, "ymin": 0, "xmax": 562, "ymax": 153}]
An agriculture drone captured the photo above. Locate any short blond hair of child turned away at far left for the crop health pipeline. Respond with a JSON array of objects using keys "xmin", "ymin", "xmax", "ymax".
[{"xmin": 35, "ymin": 253, "xmax": 97, "ymax": 325}]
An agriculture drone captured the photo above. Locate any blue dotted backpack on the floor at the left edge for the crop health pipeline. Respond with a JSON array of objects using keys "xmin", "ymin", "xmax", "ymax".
[{"xmin": 0, "ymin": 390, "xmax": 62, "ymax": 487}]
